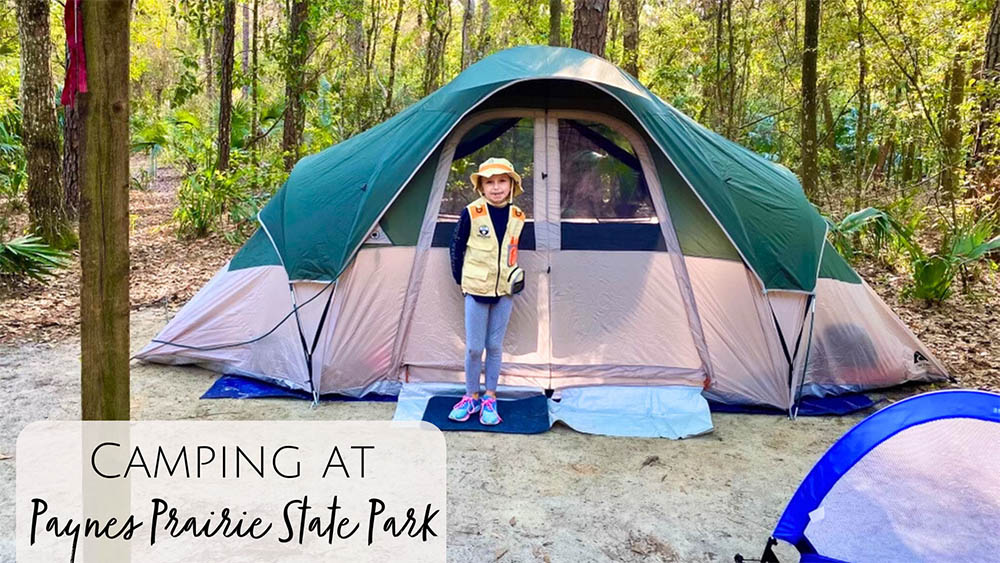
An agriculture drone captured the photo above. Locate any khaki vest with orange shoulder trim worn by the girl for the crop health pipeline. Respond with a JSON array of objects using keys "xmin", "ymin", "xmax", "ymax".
[{"xmin": 462, "ymin": 197, "xmax": 524, "ymax": 297}]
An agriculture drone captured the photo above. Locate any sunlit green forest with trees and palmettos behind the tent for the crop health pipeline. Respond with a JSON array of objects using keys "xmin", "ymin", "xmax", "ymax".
[{"xmin": 0, "ymin": 0, "xmax": 1000, "ymax": 388}]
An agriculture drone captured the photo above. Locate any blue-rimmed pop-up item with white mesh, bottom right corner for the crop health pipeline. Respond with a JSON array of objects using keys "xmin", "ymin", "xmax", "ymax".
[{"xmin": 735, "ymin": 390, "xmax": 1000, "ymax": 563}]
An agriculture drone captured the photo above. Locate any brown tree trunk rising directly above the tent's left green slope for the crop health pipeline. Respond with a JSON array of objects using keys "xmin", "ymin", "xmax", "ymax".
[{"xmin": 281, "ymin": 0, "xmax": 309, "ymax": 171}]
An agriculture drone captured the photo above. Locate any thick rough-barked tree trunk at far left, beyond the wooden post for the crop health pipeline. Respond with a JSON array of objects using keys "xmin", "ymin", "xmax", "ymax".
[{"xmin": 16, "ymin": 0, "xmax": 76, "ymax": 248}]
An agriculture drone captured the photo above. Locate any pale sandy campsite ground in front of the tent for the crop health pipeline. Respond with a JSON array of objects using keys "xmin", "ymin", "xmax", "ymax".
[{"xmin": 0, "ymin": 309, "xmax": 876, "ymax": 562}]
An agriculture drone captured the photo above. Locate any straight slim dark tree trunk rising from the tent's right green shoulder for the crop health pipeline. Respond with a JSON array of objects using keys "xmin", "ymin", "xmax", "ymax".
[{"xmin": 802, "ymin": 0, "xmax": 820, "ymax": 199}]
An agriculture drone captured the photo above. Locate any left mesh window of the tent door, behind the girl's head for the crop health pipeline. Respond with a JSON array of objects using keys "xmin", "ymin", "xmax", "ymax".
[{"xmin": 432, "ymin": 117, "xmax": 535, "ymax": 250}]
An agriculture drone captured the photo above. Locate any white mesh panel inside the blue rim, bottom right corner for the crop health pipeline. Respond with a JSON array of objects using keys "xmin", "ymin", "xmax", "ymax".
[{"xmin": 805, "ymin": 418, "xmax": 1000, "ymax": 561}]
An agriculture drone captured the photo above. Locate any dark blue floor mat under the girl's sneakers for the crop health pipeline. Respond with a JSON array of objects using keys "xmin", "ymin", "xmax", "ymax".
[{"xmin": 424, "ymin": 395, "xmax": 551, "ymax": 434}]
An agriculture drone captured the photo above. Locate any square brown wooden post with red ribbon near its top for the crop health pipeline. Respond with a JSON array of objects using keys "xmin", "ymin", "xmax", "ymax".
[{"xmin": 79, "ymin": 0, "xmax": 129, "ymax": 420}]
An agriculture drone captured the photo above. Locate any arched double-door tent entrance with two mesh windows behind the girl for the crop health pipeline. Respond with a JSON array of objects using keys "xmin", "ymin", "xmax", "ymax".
[{"xmin": 400, "ymin": 109, "xmax": 710, "ymax": 388}]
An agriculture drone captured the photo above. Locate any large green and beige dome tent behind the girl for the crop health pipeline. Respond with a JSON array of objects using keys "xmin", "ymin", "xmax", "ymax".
[{"xmin": 138, "ymin": 46, "xmax": 946, "ymax": 409}]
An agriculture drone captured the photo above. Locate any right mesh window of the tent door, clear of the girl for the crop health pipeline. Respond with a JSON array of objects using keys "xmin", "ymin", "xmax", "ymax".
[{"xmin": 559, "ymin": 119, "xmax": 666, "ymax": 251}]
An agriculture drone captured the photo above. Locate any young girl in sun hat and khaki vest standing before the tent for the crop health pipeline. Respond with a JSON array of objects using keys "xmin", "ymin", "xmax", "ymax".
[{"xmin": 448, "ymin": 158, "xmax": 524, "ymax": 425}]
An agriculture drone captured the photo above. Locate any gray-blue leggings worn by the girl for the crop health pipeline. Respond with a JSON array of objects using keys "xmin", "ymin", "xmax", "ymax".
[{"xmin": 465, "ymin": 295, "xmax": 514, "ymax": 395}]
